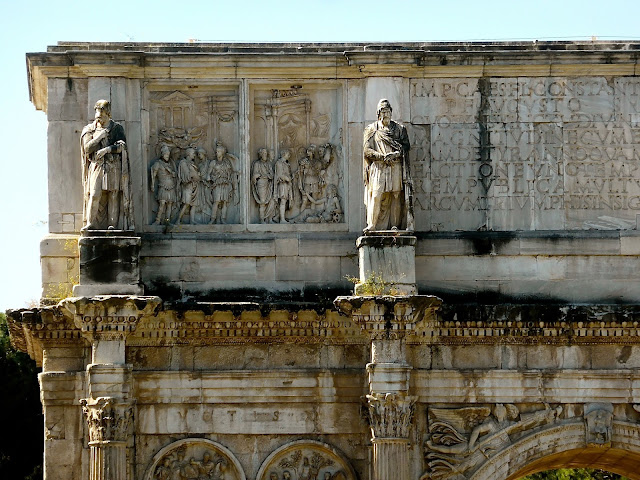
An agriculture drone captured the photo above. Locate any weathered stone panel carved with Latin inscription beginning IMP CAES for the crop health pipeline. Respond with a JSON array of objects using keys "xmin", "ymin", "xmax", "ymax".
[{"xmin": 408, "ymin": 77, "xmax": 640, "ymax": 231}]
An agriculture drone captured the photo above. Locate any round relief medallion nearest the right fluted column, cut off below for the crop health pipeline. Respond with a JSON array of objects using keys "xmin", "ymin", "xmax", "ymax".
[{"xmin": 256, "ymin": 440, "xmax": 356, "ymax": 480}]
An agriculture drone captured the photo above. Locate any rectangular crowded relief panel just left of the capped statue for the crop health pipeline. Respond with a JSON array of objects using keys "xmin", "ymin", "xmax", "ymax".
[{"xmin": 250, "ymin": 86, "xmax": 344, "ymax": 224}]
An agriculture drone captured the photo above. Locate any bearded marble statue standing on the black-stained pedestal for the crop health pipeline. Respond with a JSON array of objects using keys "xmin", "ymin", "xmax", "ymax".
[{"xmin": 80, "ymin": 100, "xmax": 133, "ymax": 231}]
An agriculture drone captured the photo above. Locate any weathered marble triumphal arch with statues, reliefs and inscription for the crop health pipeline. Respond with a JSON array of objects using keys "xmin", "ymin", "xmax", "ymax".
[{"xmin": 9, "ymin": 42, "xmax": 640, "ymax": 480}]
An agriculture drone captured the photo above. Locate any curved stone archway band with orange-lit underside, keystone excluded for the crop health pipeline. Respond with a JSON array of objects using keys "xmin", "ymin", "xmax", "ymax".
[{"xmin": 469, "ymin": 421, "xmax": 640, "ymax": 480}]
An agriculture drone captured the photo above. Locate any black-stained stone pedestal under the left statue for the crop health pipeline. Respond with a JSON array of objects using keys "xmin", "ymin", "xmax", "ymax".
[{"xmin": 73, "ymin": 230, "xmax": 143, "ymax": 297}]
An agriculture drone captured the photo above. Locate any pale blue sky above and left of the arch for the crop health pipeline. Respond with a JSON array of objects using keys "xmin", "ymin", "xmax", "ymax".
[{"xmin": 0, "ymin": 0, "xmax": 640, "ymax": 311}]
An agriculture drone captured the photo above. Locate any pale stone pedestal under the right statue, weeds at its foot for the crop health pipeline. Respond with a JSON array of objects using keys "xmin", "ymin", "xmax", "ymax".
[{"xmin": 354, "ymin": 231, "xmax": 418, "ymax": 295}]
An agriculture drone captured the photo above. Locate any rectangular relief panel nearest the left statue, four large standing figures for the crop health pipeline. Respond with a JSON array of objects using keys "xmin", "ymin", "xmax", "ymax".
[{"xmin": 148, "ymin": 87, "xmax": 242, "ymax": 228}]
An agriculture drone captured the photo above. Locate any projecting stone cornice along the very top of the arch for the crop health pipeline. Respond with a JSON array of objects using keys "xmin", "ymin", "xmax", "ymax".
[{"xmin": 27, "ymin": 41, "xmax": 640, "ymax": 111}]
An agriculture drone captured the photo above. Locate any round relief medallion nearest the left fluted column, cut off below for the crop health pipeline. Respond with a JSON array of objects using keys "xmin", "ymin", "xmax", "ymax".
[{"xmin": 145, "ymin": 438, "xmax": 246, "ymax": 480}]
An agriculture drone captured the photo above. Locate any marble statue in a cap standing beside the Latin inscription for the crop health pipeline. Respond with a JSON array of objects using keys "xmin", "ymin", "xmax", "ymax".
[{"xmin": 363, "ymin": 99, "xmax": 414, "ymax": 233}]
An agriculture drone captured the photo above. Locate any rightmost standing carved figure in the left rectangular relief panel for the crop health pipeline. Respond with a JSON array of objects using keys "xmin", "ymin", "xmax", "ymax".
[{"xmin": 206, "ymin": 142, "xmax": 240, "ymax": 223}]
